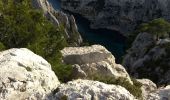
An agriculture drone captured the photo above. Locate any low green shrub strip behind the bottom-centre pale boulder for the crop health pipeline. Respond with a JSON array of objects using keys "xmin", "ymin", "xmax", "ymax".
[{"xmin": 93, "ymin": 76, "xmax": 142, "ymax": 99}]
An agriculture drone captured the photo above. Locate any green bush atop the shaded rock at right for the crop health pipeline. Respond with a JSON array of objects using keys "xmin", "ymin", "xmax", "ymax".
[{"xmin": 127, "ymin": 18, "xmax": 170, "ymax": 49}]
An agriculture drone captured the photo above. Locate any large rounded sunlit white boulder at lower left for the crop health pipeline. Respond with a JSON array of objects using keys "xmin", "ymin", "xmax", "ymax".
[{"xmin": 0, "ymin": 48, "xmax": 60, "ymax": 100}]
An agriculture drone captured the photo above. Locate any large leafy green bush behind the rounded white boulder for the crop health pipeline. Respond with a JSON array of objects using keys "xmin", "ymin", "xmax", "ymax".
[{"xmin": 0, "ymin": 0, "xmax": 71, "ymax": 81}]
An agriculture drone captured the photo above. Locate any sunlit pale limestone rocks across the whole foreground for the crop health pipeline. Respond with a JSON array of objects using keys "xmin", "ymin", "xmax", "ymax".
[{"xmin": 0, "ymin": 45, "xmax": 170, "ymax": 100}]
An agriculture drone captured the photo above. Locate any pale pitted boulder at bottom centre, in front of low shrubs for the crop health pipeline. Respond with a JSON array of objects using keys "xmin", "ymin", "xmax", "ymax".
[{"xmin": 54, "ymin": 79, "xmax": 134, "ymax": 100}]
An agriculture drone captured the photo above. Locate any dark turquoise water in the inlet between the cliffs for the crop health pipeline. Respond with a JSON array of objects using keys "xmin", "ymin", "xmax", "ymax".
[{"xmin": 48, "ymin": 0, "xmax": 126, "ymax": 62}]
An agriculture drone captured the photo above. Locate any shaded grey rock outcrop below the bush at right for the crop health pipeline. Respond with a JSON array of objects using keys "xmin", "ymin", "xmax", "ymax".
[{"xmin": 123, "ymin": 33, "xmax": 170, "ymax": 85}]
